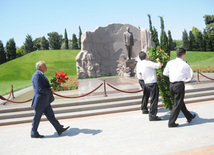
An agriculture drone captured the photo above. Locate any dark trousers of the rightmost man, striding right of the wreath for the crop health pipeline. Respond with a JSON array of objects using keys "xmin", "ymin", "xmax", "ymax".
[{"xmin": 168, "ymin": 82, "xmax": 193, "ymax": 125}]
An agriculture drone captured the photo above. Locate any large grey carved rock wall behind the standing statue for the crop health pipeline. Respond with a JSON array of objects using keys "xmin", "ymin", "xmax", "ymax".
[{"xmin": 76, "ymin": 24, "xmax": 152, "ymax": 78}]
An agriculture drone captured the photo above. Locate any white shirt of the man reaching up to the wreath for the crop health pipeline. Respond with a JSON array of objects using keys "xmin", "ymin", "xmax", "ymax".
[{"xmin": 136, "ymin": 60, "xmax": 159, "ymax": 84}]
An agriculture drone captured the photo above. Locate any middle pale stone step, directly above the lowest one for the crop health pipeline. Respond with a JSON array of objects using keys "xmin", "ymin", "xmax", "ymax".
[{"xmin": 0, "ymin": 90, "xmax": 214, "ymax": 119}]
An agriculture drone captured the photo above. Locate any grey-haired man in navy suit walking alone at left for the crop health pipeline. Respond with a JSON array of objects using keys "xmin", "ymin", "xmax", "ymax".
[{"xmin": 31, "ymin": 61, "xmax": 69, "ymax": 138}]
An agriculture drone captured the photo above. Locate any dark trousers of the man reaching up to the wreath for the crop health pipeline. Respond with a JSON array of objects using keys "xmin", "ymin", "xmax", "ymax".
[{"xmin": 141, "ymin": 83, "xmax": 159, "ymax": 118}]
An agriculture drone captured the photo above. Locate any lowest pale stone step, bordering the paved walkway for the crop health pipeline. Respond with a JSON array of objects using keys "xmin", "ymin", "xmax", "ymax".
[{"xmin": 0, "ymin": 95, "xmax": 214, "ymax": 126}]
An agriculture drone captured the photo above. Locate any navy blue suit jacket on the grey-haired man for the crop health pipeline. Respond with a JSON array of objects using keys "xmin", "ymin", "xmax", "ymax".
[{"xmin": 32, "ymin": 70, "xmax": 54, "ymax": 108}]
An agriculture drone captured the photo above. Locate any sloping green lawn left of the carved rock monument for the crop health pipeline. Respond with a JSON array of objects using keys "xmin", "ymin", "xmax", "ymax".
[{"xmin": 0, "ymin": 50, "xmax": 79, "ymax": 95}]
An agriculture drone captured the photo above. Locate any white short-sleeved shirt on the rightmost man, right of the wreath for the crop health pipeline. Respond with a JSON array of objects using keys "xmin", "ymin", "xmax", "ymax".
[{"xmin": 163, "ymin": 58, "xmax": 193, "ymax": 83}]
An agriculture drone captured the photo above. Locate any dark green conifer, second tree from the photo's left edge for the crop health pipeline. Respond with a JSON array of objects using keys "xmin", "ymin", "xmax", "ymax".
[{"xmin": 6, "ymin": 38, "xmax": 16, "ymax": 60}]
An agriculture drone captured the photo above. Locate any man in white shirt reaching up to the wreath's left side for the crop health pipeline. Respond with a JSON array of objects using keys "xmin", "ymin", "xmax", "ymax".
[{"xmin": 137, "ymin": 52, "xmax": 162, "ymax": 121}]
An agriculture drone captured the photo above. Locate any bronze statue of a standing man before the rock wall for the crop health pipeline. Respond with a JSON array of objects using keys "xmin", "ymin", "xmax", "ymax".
[{"xmin": 123, "ymin": 27, "xmax": 134, "ymax": 59}]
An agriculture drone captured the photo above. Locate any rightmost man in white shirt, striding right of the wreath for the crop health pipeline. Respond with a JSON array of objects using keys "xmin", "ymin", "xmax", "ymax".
[{"xmin": 163, "ymin": 48, "xmax": 196, "ymax": 127}]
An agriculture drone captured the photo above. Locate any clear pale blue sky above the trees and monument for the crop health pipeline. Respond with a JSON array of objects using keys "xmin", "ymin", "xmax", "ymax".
[{"xmin": 0, "ymin": 0, "xmax": 214, "ymax": 47}]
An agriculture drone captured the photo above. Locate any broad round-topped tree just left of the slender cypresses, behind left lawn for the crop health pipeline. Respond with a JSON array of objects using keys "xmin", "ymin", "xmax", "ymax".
[{"xmin": 48, "ymin": 32, "xmax": 63, "ymax": 50}]
